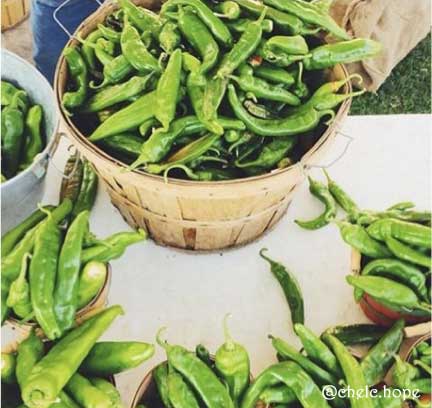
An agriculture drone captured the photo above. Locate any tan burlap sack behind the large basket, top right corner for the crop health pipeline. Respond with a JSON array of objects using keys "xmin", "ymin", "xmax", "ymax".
[{"xmin": 331, "ymin": 0, "xmax": 431, "ymax": 91}]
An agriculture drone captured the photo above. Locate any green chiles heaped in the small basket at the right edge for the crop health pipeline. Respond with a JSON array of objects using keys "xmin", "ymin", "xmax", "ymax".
[{"xmin": 296, "ymin": 173, "xmax": 432, "ymax": 326}]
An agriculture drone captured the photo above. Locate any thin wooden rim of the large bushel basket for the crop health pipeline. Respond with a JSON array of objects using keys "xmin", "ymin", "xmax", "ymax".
[{"xmin": 54, "ymin": 3, "xmax": 352, "ymax": 188}]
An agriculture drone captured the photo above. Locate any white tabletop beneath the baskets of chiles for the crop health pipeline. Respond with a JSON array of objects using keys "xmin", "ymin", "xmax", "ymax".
[{"xmin": 2, "ymin": 115, "xmax": 431, "ymax": 406}]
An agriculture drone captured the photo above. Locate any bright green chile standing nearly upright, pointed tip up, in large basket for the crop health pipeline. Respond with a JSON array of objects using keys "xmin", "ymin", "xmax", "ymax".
[{"xmin": 155, "ymin": 49, "xmax": 182, "ymax": 130}]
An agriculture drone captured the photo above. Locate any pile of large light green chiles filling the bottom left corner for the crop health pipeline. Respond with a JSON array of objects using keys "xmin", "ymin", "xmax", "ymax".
[{"xmin": 1, "ymin": 306, "xmax": 155, "ymax": 408}]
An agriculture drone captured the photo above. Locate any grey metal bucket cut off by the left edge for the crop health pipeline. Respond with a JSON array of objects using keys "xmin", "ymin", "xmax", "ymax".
[{"xmin": 0, "ymin": 50, "xmax": 59, "ymax": 235}]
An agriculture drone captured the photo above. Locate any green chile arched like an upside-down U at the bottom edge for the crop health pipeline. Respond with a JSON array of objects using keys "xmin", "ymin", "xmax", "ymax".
[{"xmin": 240, "ymin": 361, "xmax": 329, "ymax": 408}]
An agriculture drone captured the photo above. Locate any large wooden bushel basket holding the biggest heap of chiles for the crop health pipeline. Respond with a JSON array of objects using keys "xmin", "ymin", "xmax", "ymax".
[{"xmin": 54, "ymin": 0, "xmax": 351, "ymax": 250}]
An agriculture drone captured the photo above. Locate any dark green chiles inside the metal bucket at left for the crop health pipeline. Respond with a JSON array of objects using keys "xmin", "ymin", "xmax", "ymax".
[{"xmin": 1, "ymin": 80, "xmax": 46, "ymax": 183}]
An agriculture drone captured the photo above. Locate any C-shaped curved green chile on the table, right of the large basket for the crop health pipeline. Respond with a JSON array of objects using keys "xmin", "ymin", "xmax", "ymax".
[{"xmin": 295, "ymin": 177, "xmax": 337, "ymax": 230}]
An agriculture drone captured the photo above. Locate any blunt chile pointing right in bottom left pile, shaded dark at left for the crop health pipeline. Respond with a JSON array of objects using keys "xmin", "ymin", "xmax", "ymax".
[{"xmin": 80, "ymin": 341, "xmax": 155, "ymax": 377}]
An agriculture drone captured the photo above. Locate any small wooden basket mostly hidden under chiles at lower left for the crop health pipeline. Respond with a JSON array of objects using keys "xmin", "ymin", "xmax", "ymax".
[{"xmin": 5, "ymin": 264, "xmax": 111, "ymax": 336}]
